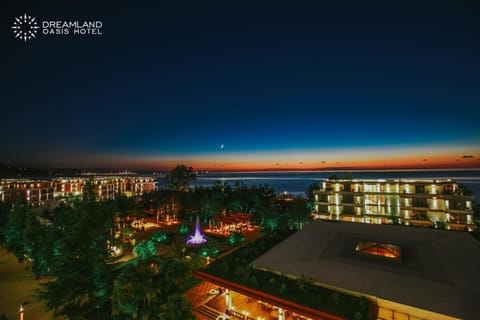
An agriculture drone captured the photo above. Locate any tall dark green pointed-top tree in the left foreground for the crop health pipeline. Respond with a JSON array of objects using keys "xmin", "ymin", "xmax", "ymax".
[{"xmin": 39, "ymin": 199, "xmax": 117, "ymax": 319}]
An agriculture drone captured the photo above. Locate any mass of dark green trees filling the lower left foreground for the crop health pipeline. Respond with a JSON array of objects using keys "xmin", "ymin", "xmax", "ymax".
[{"xmin": 2, "ymin": 181, "xmax": 192, "ymax": 320}]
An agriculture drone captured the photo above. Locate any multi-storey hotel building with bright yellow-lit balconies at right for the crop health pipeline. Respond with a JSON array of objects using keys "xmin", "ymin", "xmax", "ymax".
[{"xmin": 314, "ymin": 179, "xmax": 474, "ymax": 230}]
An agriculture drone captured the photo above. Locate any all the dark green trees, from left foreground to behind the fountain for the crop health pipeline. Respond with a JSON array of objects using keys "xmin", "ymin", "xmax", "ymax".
[{"xmin": 0, "ymin": 166, "xmax": 310, "ymax": 320}]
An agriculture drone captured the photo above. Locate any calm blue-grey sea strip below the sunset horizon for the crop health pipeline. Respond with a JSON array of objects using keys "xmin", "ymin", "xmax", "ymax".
[{"xmin": 188, "ymin": 169, "xmax": 480, "ymax": 202}]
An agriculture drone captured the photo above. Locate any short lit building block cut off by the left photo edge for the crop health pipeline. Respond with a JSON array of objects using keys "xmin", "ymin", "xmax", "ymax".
[{"xmin": 0, "ymin": 179, "xmax": 54, "ymax": 207}]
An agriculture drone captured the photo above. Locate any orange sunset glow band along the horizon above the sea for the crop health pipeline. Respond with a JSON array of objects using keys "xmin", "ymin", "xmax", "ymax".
[{"xmin": 68, "ymin": 145, "xmax": 480, "ymax": 171}]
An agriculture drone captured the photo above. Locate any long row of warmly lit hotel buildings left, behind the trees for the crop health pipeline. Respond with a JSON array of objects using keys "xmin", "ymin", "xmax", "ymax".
[{"xmin": 0, "ymin": 176, "xmax": 155, "ymax": 207}]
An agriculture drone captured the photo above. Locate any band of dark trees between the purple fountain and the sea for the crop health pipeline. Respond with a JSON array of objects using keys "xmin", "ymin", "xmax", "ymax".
[{"xmin": 141, "ymin": 181, "xmax": 311, "ymax": 233}]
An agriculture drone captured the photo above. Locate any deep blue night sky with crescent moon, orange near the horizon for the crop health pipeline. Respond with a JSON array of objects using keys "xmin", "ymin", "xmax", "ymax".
[{"xmin": 0, "ymin": 0, "xmax": 480, "ymax": 170}]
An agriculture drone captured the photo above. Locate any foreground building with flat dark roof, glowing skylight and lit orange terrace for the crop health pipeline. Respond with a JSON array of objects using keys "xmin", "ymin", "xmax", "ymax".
[{"xmin": 191, "ymin": 220, "xmax": 480, "ymax": 320}]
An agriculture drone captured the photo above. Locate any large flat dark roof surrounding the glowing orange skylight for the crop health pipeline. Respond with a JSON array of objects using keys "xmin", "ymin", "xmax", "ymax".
[{"xmin": 253, "ymin": 220, "xmax": 480, "ymax": 319}]
